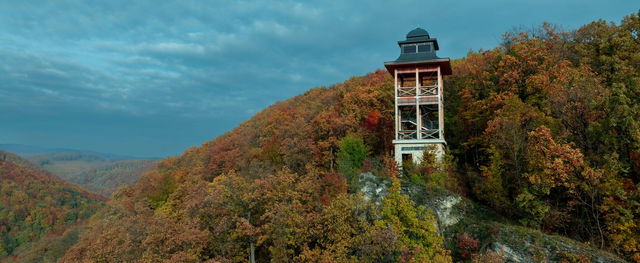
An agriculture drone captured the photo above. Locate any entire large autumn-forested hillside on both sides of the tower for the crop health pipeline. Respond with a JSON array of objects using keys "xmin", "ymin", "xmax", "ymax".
[{"xmin": 56, "ymin": 11, "xmax": 640, "ymax": 262}]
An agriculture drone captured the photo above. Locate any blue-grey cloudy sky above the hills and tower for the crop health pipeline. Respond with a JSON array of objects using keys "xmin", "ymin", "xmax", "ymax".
[{"xmin": 0, "ymin": 0, "xmax": 640, "ymax": 157}]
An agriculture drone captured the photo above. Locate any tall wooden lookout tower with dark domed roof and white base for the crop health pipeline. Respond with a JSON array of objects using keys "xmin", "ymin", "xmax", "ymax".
[{"xmin": 384, "ymin": 28, "xmax": 451, "ymax": 164}]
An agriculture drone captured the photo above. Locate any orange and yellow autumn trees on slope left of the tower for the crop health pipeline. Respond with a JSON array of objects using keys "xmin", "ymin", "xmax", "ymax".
[{"xmin": 56, "ymin": 68, "xmax": 451, "ymax": 262}]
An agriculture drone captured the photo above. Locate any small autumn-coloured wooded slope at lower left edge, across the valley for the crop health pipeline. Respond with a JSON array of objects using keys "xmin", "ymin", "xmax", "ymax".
[{"xmin": 0, "ymin": 152, "xmax": 104, "ymax": 262}]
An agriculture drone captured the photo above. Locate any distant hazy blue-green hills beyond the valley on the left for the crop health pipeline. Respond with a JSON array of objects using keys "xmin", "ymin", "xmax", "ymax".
[{"xmin": 28, "ymin": 152, "xmax": 159, "ymax": 197}]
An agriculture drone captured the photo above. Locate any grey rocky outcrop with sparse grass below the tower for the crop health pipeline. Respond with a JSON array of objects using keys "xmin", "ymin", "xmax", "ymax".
[{"xmin": 360, "ymin": 173, "xmax": 626, "ymax": 263}]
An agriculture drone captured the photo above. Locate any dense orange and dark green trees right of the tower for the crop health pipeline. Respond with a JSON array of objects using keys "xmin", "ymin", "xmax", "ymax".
[{"xmin": 445, "ymin": 14, "xmax": 640, "ymax": 261}]
